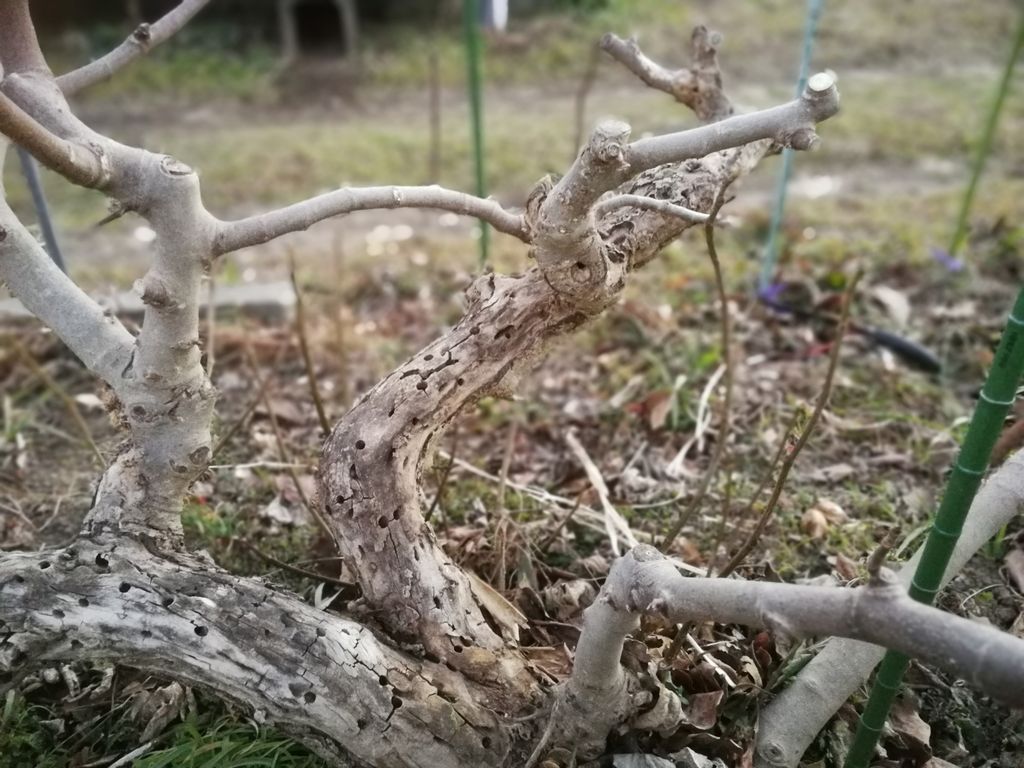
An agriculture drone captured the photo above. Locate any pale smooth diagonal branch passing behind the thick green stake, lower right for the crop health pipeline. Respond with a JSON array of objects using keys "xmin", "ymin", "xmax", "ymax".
[{"xmin": 756, "ymin": 452, "xmax": 1024, "ymax": 768}]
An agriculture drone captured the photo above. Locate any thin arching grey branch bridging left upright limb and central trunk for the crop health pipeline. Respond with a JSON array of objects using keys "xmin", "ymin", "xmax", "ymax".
[{"xmin": 214, "ymin": 185, "xmax": 527, "ymax": 256}]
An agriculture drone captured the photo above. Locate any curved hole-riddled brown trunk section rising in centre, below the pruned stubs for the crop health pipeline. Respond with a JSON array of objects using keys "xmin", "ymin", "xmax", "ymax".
[{"xmin": 321, "ymin": 269, "xmax": 589, "ymax": 695}]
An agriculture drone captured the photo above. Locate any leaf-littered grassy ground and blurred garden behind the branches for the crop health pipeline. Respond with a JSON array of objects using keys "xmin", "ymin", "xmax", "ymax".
[{"xmin": 0, "ymin": 0, "xmax": 1024, "ymax": 768}]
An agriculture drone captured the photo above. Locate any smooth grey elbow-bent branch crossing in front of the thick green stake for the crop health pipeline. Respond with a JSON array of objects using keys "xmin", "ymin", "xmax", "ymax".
[{"xmin": 557, "ymin": 545, "xmax": 1024, "ymax": 761}]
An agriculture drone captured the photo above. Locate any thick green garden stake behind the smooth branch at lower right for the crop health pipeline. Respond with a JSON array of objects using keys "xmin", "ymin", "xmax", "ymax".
[{"xmin": 845, "ymin": 288, "xmax": 1024, "ymax": 768}]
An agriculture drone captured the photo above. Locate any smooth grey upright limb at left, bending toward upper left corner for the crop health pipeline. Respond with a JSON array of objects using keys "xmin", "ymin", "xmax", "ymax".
[{"xmin": 0, "ymin": 45, "xmax": 217, "ymax": 549}]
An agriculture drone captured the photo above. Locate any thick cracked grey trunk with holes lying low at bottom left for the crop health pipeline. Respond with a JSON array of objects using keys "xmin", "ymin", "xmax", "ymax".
[{"xmin": 0, "ymin": 538, "xmax": 512, "ymax": 768}]
